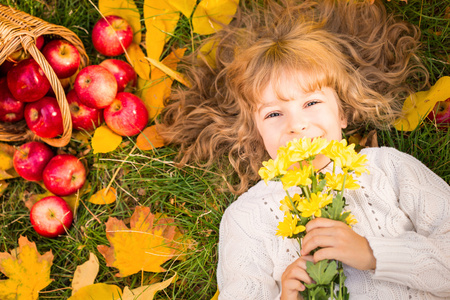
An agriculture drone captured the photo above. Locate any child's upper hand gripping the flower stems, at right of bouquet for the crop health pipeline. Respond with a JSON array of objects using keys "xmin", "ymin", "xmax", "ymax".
[{"xmin": 300, "ymin": 218, "xmax": 376, "ymax": 270}]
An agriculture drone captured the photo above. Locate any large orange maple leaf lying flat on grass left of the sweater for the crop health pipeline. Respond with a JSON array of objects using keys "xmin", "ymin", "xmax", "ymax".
[{"xmin": 97, "ymin": 207, "xmax": 182, "ymax": 277}]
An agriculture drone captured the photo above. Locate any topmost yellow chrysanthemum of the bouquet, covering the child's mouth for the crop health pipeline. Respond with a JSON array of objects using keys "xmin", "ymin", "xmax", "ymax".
[{"xmin": 286, "ymin": 137, "xmax": 328, "ymax": 162}]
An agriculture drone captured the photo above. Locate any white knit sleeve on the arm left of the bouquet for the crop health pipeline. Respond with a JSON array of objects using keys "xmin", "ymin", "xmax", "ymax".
[{"xmin": 217, "ymin": 197, "xmax": 280, "ymax": 300}]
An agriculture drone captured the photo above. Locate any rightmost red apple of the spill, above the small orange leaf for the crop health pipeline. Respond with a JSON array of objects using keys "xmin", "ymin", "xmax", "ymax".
[{"xmin": 103, "ymin": 92, "xmax": 148, "ymax": 136}]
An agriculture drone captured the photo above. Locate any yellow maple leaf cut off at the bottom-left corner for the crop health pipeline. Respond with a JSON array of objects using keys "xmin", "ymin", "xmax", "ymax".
[{"xmin": 0, "ymin": 236, "xmax": 53, "ymax": 300}]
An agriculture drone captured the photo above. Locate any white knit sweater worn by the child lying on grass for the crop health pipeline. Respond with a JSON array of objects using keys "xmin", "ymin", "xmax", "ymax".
[{"xmin": 217, "ymin": 147, "xmax": 450, "ymax": 300}]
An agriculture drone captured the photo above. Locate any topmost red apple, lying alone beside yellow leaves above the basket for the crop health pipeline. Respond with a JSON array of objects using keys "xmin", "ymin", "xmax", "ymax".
[{"xmin": 92, "ymin": 15, "xmax": 133, "ymax": 56}]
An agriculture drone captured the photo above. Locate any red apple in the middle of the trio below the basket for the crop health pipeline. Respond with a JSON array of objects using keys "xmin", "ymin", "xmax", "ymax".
[{"xmin": 42, "ymin": 154, "xmax": 86, "ymax": 196}]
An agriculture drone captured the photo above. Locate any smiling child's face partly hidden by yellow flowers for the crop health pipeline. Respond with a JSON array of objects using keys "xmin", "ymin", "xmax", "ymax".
[{"xmin": 254, "ymin": 75, "xmax": 347, "ymax": 168}]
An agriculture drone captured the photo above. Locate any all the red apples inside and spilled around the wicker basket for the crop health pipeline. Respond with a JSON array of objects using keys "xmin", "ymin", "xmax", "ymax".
[{"xmin": 0, "ymin": 15, "xmax": 148, "ymax": 237}]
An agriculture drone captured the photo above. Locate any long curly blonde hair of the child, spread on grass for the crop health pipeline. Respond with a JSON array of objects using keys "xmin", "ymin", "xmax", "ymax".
[{"xmin": 159, "ymin": 0, "xmax": 428, "ymax": 194}]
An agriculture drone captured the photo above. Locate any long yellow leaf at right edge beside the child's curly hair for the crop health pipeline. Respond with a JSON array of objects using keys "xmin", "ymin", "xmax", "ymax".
[{"xmin": 394, "ymin": 76, "xmax": 450, "ymax": 131}]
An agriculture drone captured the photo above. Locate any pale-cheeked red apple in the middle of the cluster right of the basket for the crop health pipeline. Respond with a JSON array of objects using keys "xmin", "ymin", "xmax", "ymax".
[{"xmin": 74, "ymin": 65, "xmax": 117, "ymax": 108}]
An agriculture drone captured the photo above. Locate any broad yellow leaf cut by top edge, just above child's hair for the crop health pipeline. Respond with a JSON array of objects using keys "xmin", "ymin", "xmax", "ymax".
[{"xmin": 192, "ymin": 0, "xmax": 239, "ymax": 35}]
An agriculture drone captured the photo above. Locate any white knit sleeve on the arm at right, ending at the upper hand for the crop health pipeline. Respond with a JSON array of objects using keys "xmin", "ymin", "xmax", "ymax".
[{"xmin": 368, "ymin": 148, "xmax": 450, "ymax": 298}]
